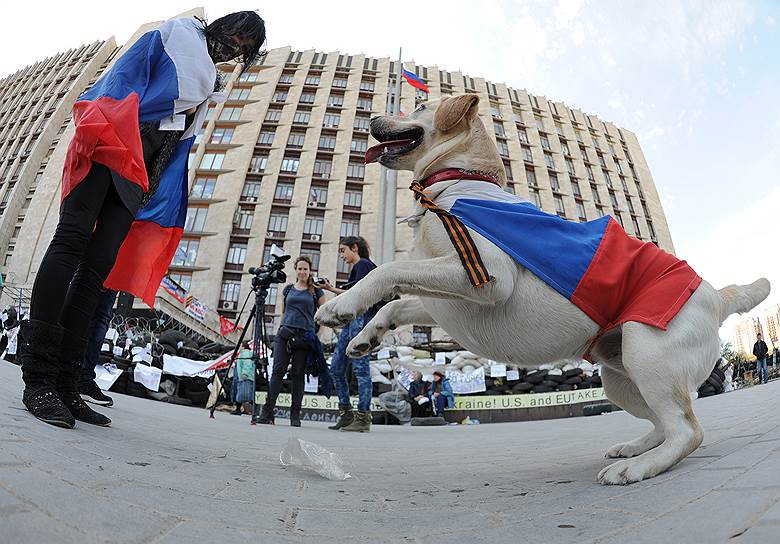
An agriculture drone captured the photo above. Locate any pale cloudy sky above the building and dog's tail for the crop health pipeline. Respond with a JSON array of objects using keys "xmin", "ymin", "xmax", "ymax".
[{"xmin": 0, "ymin": 0, "xmax": 780, "ymax": 339}]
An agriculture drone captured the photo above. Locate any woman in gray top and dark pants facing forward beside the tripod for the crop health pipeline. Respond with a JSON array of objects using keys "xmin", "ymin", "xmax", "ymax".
[{"xmin": 258, "ymin": 256, "xmax": 325, "ymax": 427}]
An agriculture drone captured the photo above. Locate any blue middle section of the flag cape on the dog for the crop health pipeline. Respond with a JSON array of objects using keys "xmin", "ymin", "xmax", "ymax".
[{"xmin": 450, "ymin": 199, "xmax": 609, "ymax": 299}]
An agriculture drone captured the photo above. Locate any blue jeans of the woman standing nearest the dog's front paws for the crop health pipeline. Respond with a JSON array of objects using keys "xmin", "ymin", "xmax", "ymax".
[{"xmin": 330, "ymin": 310, "xmax": 374, "ymax": 412}]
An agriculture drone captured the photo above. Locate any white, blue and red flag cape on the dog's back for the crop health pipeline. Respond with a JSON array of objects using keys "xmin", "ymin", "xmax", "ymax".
[{"xmin": 413, "ymin": 176, "xmax": 701, "ymax": 344}]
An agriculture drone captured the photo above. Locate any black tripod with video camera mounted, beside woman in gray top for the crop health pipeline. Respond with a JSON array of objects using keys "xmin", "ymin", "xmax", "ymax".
[{"xmin": 209, "ymin": 255, "xmax": 290, "ymax": 425}]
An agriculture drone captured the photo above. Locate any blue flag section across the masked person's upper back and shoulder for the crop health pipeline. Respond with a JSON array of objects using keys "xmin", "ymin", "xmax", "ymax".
[{"xmin": 79, "ymin": 30, "xmax": 179, "ymax": 122}]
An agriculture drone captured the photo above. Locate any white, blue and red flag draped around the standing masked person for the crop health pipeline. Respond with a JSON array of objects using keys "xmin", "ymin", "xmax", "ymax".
[{"xmin": 62, "ymin": 18, "xmax": 220, "ymax": 306}]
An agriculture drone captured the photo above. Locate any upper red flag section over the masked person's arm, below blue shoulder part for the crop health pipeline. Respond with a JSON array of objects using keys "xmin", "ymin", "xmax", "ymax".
[{"xmin": 62, "ymin": 93, "xmax": 149, "ymax": 199}]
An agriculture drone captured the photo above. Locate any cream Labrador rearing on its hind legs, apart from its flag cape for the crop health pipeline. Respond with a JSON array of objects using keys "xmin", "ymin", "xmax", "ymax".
[{"xmin": 316, "ymin": 94, "xmax": 769, "ymax": 484}]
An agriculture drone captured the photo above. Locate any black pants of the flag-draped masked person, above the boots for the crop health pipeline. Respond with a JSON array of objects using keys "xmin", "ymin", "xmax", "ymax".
[{"xmin": 30, "ymin": 163, "xmax": 133, "ymax": 339}]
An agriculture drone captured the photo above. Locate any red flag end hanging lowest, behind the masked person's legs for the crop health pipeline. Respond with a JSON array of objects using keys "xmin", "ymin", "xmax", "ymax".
[{"xmin": 104, "ymin": 221, "xmax": 184, "ymax": 308}]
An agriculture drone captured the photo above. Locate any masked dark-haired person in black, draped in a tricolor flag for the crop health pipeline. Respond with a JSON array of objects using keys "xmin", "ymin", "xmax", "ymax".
[{"xmin": 19, "ymin": 11, "xmax": 265, "ymax": 428}]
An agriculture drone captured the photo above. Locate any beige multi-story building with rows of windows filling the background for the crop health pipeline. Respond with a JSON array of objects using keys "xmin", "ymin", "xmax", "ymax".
[{"xmin": 0, "ymin": 10, "xmax": 674, "ymax": 342}]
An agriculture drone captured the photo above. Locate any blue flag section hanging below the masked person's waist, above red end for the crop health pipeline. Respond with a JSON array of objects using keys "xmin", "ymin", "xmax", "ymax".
[{"xmin": 136, "ymin": 136, "xmax": 195, "ymax": 228}]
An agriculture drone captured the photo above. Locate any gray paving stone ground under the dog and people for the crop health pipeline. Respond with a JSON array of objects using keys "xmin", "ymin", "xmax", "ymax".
[{"xmin": 0, "ymin": 362, "xmax": 780, "ymax": 544}]
